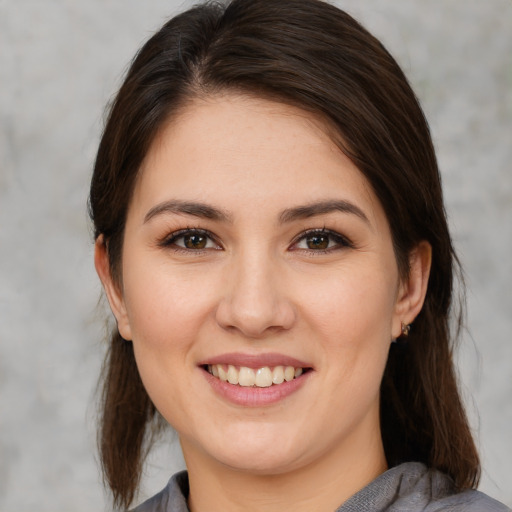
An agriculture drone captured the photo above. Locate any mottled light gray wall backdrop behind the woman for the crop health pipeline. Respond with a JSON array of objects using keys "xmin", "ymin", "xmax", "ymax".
[{"xmin": 0, "ymin": 0, "xmax": 512, "ymax": 512}]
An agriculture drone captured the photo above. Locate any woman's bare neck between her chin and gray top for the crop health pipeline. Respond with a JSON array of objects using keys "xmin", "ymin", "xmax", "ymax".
[{"xmin": 182, "ymin": 424, "xmax": 387, "ymax": 512}]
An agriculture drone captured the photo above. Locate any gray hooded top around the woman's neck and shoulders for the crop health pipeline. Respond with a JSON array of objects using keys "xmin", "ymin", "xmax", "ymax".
[{"xmin": 132, "ymin": 462, "xmax": 512, "ymax": 512}]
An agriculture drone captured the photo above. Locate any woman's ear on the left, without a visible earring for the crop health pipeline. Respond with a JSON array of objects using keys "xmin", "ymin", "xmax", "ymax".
[{"xmin": 94, "ymin": 235, "xmax": 132, "ymax": 340}]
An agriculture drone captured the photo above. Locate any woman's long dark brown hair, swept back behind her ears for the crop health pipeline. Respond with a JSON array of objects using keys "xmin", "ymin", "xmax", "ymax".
[{"xmin": 90, "ymin": 0, "xmax": 480, "ymax": 506}]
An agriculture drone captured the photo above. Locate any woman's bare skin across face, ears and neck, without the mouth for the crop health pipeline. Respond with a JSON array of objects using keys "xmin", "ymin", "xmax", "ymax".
[{"xmin": 95, "ymin": 94, "xmax": 430, "ymax": 512}]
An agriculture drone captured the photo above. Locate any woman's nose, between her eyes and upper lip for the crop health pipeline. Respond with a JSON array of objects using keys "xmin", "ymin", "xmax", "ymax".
[{"xmin": 216, "ymin": 249, "xmax": 296, "ymax": 338}]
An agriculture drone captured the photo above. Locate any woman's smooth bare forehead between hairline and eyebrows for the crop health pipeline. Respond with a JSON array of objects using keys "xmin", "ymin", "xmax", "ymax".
[{"xmin": 134, "ymin": 94, "xmax": 380, "ymax": 227}]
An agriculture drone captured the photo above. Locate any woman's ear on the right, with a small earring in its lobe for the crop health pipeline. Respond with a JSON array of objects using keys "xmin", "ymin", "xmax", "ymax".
[{"xmin": 392, "ymin": 241, "xmax": 432, "ymax": 339}]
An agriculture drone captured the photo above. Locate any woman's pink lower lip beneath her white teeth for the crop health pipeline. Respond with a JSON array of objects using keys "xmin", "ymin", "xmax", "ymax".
[{"xmin": 203, "ymin": 370, "xmax": 313, "ymax": 407}]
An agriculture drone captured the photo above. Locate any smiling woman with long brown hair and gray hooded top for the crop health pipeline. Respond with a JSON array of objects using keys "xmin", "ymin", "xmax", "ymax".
[{"xmin": 90, "ymin": 0, "xmax": 507, "ymax": 512}]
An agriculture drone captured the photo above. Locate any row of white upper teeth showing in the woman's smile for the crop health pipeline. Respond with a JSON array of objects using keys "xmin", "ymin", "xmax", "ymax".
[{"xmin": 208, "ymin": 364, "xmax": 303, "ymax": 388}]
